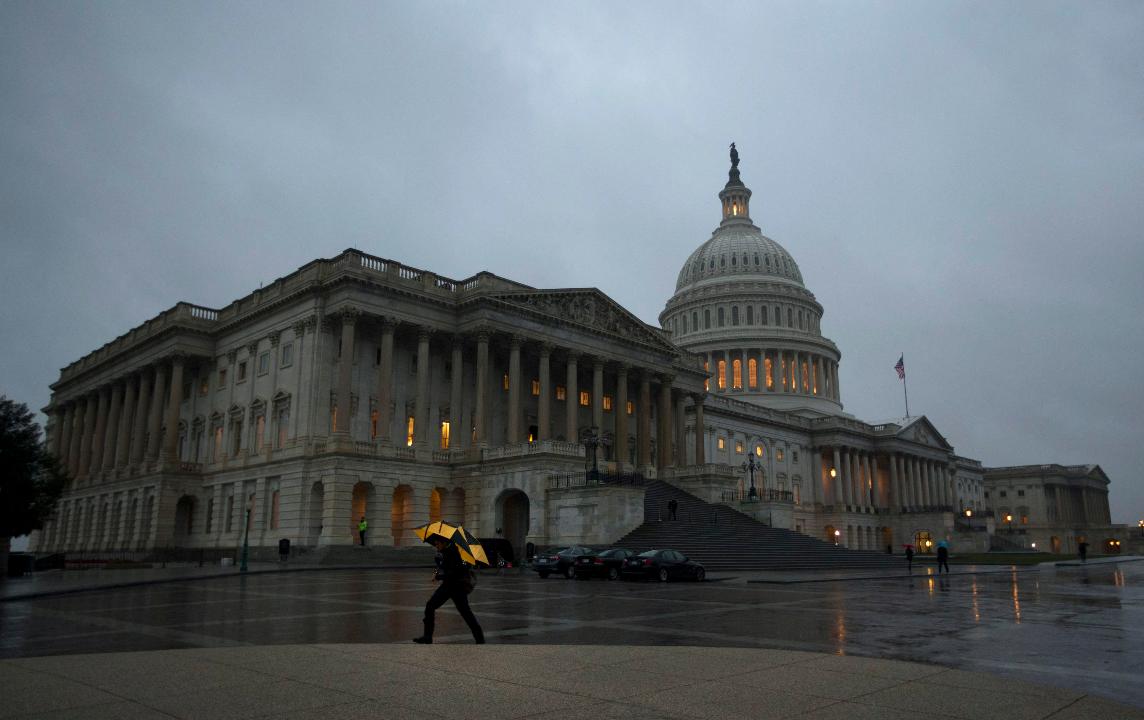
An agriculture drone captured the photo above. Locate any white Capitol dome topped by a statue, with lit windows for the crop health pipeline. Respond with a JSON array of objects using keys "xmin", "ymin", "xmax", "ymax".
[{"xmin": 659, "ymin": 144, "xmax": 842, "ymax": 416}]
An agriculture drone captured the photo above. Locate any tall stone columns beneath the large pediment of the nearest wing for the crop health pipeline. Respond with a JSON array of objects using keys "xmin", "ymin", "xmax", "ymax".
[{"xmin": 334, "ymin": 309, "xmax": 702, "ymax": 467}]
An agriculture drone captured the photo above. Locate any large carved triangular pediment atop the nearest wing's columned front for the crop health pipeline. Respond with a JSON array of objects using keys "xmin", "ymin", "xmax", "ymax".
[{"xmin": 494, "ymin": 288, "xmax": 680, "ymax": 355}]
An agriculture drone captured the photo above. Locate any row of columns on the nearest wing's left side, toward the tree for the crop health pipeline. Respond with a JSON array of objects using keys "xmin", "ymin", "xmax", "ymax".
[{"xmin": 53, "ymin": 355, "xmax": 185, "ymax": 477}]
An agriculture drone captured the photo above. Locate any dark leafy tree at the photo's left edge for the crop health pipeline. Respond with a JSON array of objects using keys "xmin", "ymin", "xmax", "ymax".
[{"xmin": 0, "ymin": 395, "xmax": 67, "ymax": 581}]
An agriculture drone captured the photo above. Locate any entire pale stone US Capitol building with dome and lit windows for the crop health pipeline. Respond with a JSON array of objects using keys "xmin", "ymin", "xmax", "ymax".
[{"xmin": 32, "ymin": 145, "xmax": 1114, "ymax": 553}]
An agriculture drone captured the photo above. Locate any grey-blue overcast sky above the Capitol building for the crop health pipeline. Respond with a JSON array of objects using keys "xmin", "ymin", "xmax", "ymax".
[{"xmin": 0, "ymin": 0, "xmax": 1144, "ymax": 524}]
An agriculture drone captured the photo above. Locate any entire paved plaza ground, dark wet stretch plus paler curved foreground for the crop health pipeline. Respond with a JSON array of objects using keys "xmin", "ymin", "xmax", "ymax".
[{"xmin": 0, "ymin": 563, "xmax": 1144, "ymax": 720}]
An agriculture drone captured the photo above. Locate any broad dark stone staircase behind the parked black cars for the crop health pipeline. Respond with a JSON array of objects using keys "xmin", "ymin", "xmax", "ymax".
[{"xmin": 614, "ymin": 481, "xmax": 905, "ymax": 571}]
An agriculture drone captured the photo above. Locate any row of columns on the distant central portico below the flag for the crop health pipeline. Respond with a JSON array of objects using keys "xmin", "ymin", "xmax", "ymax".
[{"xmin": 823, "ymin": 446, "xmax": 954, "ymax": 509}]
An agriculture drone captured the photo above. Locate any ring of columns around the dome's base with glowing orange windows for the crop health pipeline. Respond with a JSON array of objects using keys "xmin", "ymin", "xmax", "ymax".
[{"xmin": 707, "ymin": 348, "xmax": 841, "ymax": 401}]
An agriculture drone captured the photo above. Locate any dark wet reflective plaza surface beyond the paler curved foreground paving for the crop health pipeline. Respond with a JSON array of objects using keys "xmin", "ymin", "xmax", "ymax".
[{"xmin": 0, "ymin": 562, "xmax": 1144, "ymax": 707}]
